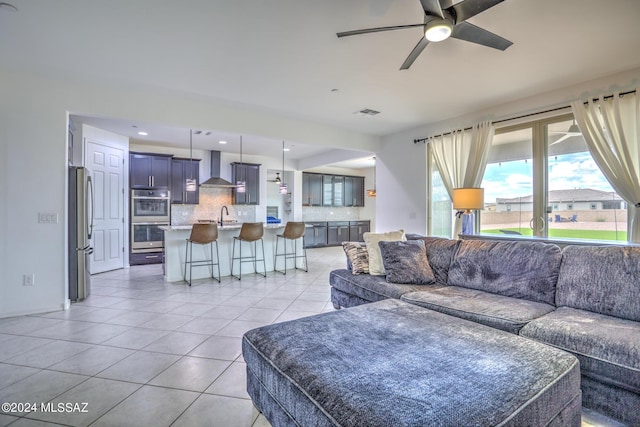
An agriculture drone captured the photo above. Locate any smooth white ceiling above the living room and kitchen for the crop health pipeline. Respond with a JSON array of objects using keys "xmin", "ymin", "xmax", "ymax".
[{"xmin": 0, "ymin": 0, "xmax": 640, "ymax": 171}]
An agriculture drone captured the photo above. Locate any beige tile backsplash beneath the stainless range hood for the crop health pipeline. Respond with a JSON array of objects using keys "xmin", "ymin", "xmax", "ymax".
[{"xmin": 171, "ymin": 187, "xmax": 256, "ymax": 225}]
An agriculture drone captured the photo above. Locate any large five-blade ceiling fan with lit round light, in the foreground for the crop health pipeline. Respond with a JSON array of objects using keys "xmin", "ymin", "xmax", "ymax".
[{"xmin": 337, "ymin": 0, "xmax": 513, "ymax": 70}]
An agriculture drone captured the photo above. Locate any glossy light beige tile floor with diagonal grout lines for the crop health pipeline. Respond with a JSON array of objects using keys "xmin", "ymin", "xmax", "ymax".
[{"xmin": 0, "ymin": 248, "xmax": 628, "ymax": 427}]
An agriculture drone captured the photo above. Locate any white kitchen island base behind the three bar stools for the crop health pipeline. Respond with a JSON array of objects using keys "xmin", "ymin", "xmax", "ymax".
[{"xmin": 160, "ymin": 223, "xmax": 302, "ymax": 282}]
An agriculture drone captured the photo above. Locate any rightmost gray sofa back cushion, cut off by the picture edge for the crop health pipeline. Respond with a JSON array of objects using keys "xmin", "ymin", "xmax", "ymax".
[{"xmin": 556, "ymin": 246, "xmax": 640, "ymax": 321}]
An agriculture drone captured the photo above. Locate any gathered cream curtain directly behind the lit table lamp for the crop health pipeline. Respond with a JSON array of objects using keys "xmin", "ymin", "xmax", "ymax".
[{"xmin": 429, "ymin": 121, "xmax": 495, "ymax": 237}]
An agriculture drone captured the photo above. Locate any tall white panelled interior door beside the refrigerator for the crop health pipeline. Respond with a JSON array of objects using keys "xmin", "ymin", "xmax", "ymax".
[{"xmin": 85, "ymin": 138, "xmax": 125, "ymax": 274}]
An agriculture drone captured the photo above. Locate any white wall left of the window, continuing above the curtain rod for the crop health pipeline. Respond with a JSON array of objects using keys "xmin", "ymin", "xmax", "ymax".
[{"xmin": 376, "ymin": 68, "xmax": 640, "ymax": 234}]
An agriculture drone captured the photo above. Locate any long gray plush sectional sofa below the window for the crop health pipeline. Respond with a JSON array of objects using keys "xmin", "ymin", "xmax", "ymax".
[{"xmin": 330, "ymin": 236, "xmax": 640, "ymax": 426}]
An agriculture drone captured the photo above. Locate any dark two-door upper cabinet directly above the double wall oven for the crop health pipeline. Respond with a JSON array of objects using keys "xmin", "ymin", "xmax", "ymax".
[{"xmin": 129, "ymin": 152, "xmax": 172, "ymax": 188}]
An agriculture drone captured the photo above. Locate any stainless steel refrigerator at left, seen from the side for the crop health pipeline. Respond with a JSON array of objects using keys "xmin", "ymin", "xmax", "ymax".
[{"xmin": 68, "ymin": 166, "xmax": 94, "ymax": 301}]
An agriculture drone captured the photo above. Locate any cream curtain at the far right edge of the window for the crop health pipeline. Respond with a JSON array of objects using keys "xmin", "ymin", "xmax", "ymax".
[{"xmin": 571, "ymin": 89, "xmax": 640, "ymax": 243}]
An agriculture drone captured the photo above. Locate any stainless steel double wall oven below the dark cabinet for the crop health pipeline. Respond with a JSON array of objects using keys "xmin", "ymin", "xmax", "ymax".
[{"xmin": 131, "ymin": 189, "xmax": 171, "ymax": 257}]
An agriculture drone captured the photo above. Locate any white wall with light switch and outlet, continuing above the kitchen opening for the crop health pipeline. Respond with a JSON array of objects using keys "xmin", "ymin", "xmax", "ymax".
[{"xmin": 0, "ymin": 71, "xmax": 380, "ymax": 317}]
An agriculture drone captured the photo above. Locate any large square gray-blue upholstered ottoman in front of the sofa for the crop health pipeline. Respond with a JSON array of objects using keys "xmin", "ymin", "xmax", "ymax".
[{"xmin": 242, "ymin": 300, "xmax": 581, "ymax": 427}]
